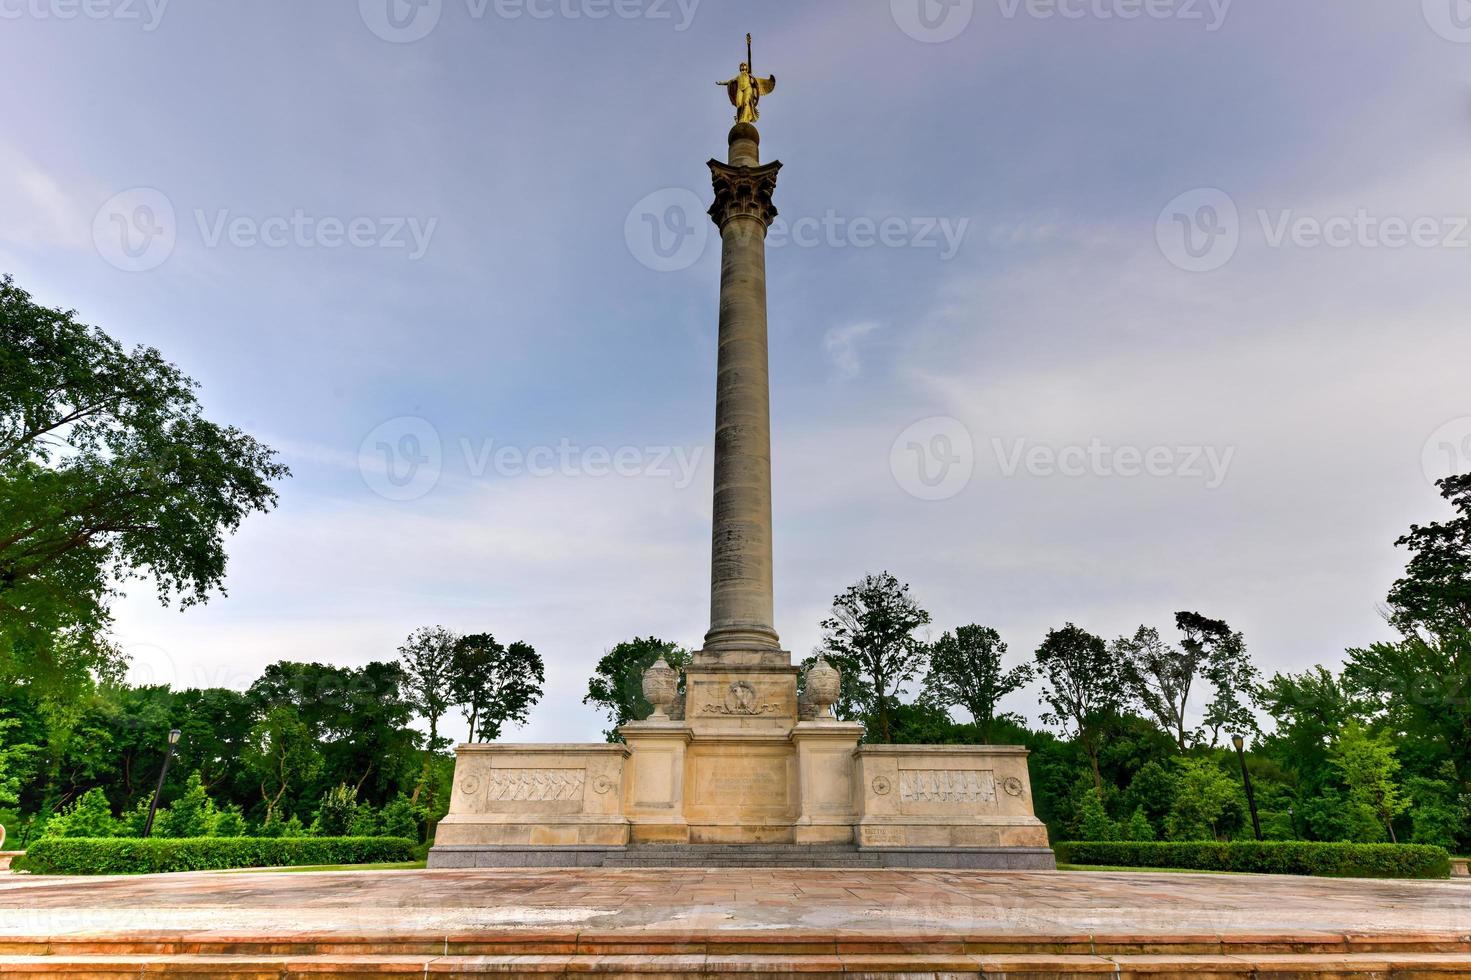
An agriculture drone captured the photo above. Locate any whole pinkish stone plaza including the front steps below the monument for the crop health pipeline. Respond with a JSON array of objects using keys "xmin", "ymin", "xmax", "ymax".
[{"xmin": 0, "ymin": 870, "xmax": 1471, "ymax": 977}]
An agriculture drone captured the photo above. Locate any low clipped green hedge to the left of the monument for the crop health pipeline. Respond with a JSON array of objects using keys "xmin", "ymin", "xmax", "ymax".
[{"xmin": 25, "ymin": 837, "xmax": 413, "ymax": 874}]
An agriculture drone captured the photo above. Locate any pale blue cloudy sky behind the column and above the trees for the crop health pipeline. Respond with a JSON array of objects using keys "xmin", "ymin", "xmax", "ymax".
[{"xmin": 0, "ymin": 0, "xmax": 1471, "ymax": 742}]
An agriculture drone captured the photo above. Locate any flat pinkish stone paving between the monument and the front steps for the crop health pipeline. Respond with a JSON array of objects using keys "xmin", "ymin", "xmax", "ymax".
[{"xmin": 0, "ymin": 868, "xmax": 1471, "ymax": 949}]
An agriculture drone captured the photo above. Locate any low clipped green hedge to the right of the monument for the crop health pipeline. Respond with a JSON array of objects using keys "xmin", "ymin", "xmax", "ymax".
[{"xmin": 1053, "ymin": 840, "xmax": 1450, "ymax": 878}]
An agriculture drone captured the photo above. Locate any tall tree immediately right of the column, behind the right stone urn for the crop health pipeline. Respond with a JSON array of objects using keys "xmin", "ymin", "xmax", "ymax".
[{"xmin": 821, "ymin": 571, "xmax": 930, "ymax": 743}]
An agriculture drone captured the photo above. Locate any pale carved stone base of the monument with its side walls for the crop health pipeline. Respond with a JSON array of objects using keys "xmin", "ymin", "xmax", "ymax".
[{"xmin": 430, "ymin": 706, "xmax": 1055, "ymax": 870}]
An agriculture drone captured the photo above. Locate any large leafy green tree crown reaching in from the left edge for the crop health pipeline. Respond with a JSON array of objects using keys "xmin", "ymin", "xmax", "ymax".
[{"xmin": 0, "ymin": 277, "xmax": 288, "ymax": 656}]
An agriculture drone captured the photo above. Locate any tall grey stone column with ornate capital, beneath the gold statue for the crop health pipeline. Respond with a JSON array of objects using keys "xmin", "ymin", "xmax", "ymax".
[{"xmin": 705, "ymin": 122, "xmax": 781, "ymax": 658}]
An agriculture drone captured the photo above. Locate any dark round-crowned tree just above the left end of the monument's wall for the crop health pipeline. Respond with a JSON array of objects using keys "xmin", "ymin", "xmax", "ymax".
[{"xmin": 450, "ymin": 633, "xmax": 546, "ymax": 742}]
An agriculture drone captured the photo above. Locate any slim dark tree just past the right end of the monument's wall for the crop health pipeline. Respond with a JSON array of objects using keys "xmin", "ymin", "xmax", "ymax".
[{"xmin": 1037, "ymin": 622, "xmax": 1125, "ymax": 792}]
